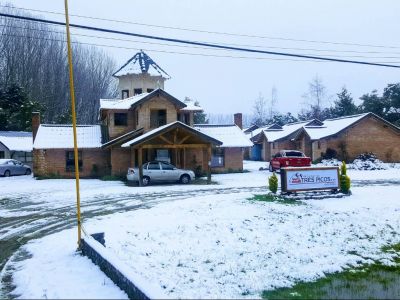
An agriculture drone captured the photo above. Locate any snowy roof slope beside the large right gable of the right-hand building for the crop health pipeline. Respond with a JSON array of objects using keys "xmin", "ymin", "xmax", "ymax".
[{"xmin": 304, "ymin": 113, "xmax": 369, "ymax": 140}]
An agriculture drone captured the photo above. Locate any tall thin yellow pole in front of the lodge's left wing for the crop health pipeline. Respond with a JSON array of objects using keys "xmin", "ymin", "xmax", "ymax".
[{"xmin": 64, "ymin": 0, "xmax": 81, "ymax": 249}]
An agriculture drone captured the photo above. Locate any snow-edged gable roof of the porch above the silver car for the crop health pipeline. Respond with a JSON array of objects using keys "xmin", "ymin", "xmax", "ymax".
[{"xmin": 121, "ymin": 121, "xmax": 222, "ymax": 147}]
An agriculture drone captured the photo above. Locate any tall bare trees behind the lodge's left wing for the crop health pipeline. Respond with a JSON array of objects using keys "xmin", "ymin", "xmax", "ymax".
[{"xmin": 0, "ymin": 8, "xmax": 116, "ymax": 130}]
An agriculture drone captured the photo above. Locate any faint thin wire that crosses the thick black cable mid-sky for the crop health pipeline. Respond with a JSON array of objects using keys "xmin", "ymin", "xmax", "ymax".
[{"xmin": 4, "ymin": 20, "xmax": 400, "ymax": 58}]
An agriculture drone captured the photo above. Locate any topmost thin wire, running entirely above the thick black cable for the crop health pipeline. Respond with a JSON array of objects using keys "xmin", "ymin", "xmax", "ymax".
[{"xmin": 0, "ymin": 5, "xmax": 400, "ymax": 49}]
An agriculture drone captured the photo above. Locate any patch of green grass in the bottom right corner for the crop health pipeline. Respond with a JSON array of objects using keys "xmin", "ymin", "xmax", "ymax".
[{"xmin": 262, "ymin": 263, "xmax": 400, "ymax": 299}]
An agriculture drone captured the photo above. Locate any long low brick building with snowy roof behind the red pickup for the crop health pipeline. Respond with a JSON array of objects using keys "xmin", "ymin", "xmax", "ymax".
[{"xmin": 250, "ymin": 113, "xmax": 400, "ymax": 162}]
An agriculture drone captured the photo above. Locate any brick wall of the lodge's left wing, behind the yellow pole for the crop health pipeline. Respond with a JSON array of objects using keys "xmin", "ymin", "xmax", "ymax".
[{"xmin": 33, "ymin": 149, "xmax": 110, "ymax": 178}]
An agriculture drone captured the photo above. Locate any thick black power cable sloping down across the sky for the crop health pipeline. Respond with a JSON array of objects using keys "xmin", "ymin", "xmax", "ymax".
[{"xmin": 0, "ymin": 13, "xmax": 400, "ymax": 68}]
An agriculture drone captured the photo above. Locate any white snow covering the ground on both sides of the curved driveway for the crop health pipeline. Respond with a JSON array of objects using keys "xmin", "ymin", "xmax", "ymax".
[{"xmin": 0, "ymin": 162, "xmax": 400, "ymax": 298}]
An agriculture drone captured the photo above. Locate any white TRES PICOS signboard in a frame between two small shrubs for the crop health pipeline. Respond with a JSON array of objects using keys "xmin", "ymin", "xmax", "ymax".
[{"xmin": 281, "ymin": 167, "xmax": 339, "ymax": 192}]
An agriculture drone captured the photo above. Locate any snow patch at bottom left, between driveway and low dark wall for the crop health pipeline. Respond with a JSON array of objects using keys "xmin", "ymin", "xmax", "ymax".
[{"xmin": 9, "ymin": 229, "xmax": 127, "ymax": 299}]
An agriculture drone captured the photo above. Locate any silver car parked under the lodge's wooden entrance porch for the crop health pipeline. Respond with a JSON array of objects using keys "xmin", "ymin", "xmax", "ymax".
[{"xmin": 126, "ymin": 161, "xmax": 195, "ymax": 186}]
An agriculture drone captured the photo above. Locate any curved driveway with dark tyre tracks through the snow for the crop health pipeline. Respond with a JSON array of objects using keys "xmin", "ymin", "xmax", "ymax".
[{"xmin": 0, "ymin": 180, "xmax": 400, "ymax": 298}]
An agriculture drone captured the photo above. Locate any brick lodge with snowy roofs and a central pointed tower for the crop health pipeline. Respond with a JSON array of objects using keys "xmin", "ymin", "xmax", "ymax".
[{"xmin": 32, "ymin": 52, "xmax": 252, "ymax": 177}]
